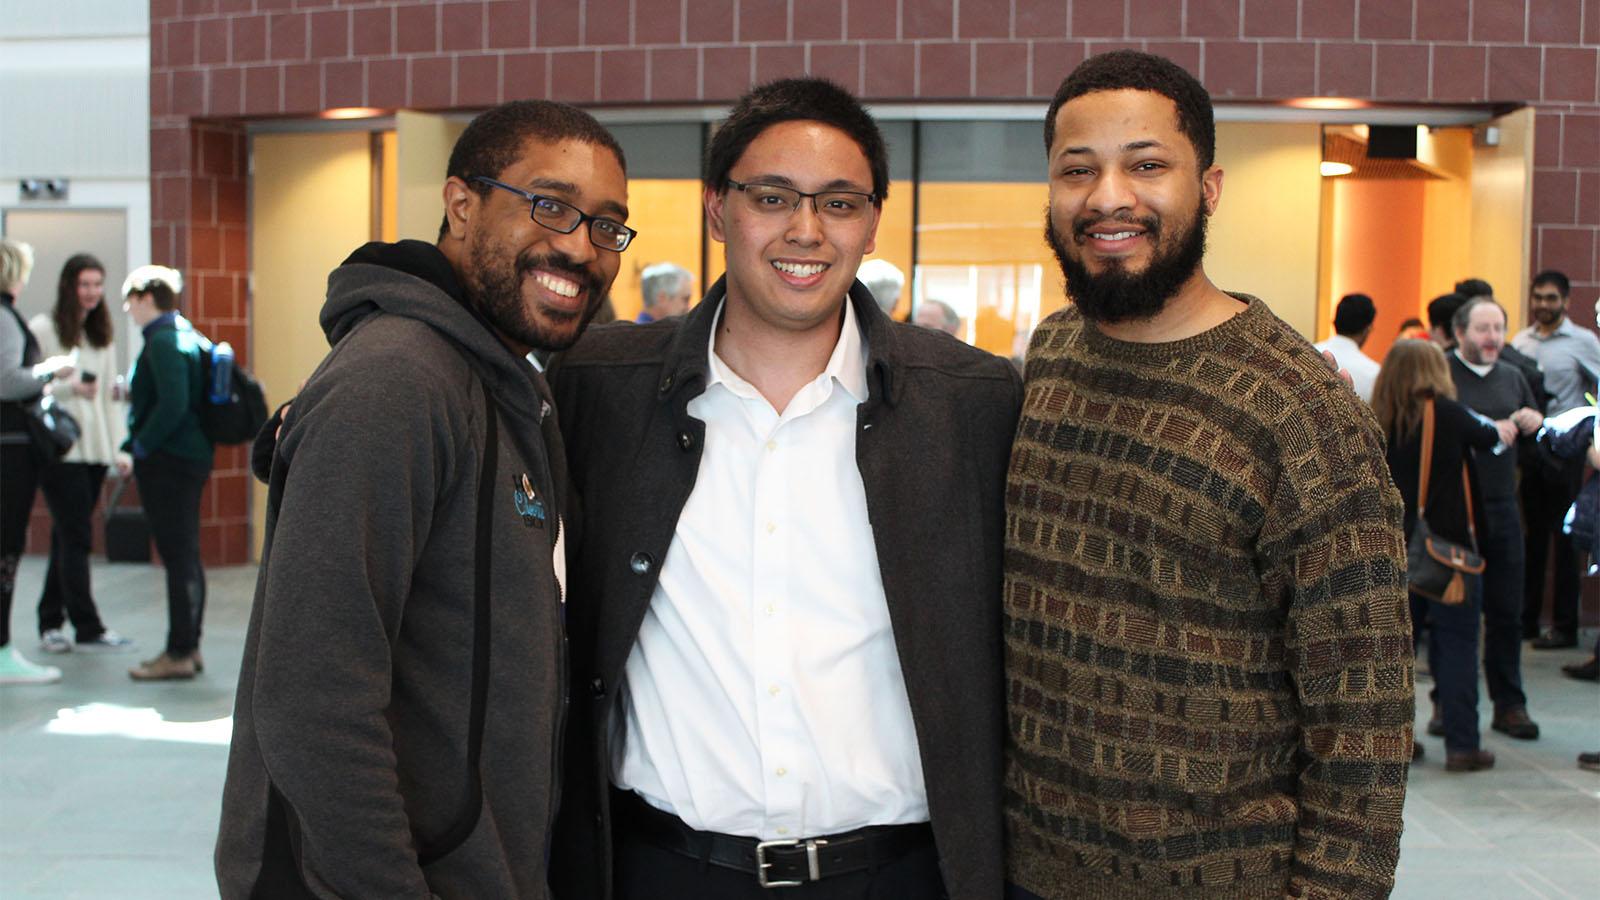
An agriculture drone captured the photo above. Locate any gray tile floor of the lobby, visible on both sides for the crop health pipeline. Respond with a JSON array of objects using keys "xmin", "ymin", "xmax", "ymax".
[{"xmin": 0, "ymin": 559, "xmax": 1600, "ymax": 900}]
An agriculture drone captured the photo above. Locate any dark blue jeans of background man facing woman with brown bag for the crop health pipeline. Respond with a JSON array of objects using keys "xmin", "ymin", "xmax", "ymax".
[{"xmin": 1478, "ymin": 496, "xmax": 1528, "ymax": 713}]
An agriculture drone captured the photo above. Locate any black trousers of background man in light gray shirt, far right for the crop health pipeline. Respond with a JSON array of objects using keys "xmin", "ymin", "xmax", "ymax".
[{"xmin": 1522, "ymin": 466, "xmax": 1584, "ymax": 634}]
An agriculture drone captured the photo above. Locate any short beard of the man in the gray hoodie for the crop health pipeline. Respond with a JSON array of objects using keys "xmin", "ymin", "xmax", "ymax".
[{"xmin": 467, "ymin": 243, "xmax": 606, "ymax": 352}]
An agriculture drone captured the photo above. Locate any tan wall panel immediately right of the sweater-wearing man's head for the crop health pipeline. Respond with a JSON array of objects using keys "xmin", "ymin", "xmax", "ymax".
[{"xmin": 1205, "ymin": 122, "xmax": 1322, "ymax": 338}]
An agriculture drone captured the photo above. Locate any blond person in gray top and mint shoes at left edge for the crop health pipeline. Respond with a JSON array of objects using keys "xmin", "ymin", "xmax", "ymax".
[{"xmin": 0, "ymin": 239, "xmax": 74, "ymax": 684}]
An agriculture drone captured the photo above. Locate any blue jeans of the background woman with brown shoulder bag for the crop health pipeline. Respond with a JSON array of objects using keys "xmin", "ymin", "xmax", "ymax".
[{"xmin": 1411, "ymin": 577, "xmax": 1483, "ymax": 753}]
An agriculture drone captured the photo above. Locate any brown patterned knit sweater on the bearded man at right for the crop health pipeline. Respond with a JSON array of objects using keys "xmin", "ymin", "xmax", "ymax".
[{"xmin": 1005, "ymin": 295, "xmax": 1411, "ymax": 900}]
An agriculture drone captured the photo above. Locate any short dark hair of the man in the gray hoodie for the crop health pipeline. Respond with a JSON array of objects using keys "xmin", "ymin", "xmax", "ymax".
[{"xmin": 438, "ymin": 99, "xmax": 627, "ymax": 237}]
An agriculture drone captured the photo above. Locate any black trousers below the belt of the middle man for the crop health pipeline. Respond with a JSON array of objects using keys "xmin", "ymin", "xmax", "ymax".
[{"xmin": 614, "ymin": 833, "xmax": 946, "ymax": 900}]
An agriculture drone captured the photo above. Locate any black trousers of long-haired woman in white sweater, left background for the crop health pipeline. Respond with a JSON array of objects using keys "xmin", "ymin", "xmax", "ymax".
[{"xmin": 38, "ymin": 463, "xmax": 106, "ymax": 641}]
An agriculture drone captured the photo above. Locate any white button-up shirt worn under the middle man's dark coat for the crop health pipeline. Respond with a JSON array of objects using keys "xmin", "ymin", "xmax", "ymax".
[{"xmin": 613, "ymin": 299, "xmax": 928, "ymax": 841}]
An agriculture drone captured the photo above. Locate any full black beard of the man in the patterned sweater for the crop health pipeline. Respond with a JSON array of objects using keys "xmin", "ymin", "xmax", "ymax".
[{"xmin": 1045, "ymin": 199, "xmax": 1206, "ymax": 325}]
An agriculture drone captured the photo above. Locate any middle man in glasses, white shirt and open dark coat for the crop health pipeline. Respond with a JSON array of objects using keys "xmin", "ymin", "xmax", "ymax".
[{"xmin": 550, "ymin": 78, "xmax": 1021, "ymax": 900}]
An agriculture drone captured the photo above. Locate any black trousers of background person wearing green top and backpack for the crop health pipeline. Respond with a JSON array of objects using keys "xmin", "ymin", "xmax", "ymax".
[{"xmin": 133, "ymin": 453, "xmax": 211, "ymax": 650}]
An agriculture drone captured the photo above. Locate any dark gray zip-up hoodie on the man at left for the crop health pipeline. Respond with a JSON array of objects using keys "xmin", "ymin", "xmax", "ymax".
[{"xmin": 216, "ymin": 242, "xmax": 566, "ymax": 900}]
